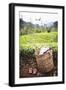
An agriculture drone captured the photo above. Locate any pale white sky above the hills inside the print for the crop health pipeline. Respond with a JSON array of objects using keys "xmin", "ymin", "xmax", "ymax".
[{"xmin": 20, "ymin": 12, "xmax": 58, "ymax": 25}]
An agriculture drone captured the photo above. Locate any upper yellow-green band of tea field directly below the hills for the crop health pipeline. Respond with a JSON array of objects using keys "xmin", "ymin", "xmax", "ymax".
[{"xmin": 20, "ymin": 32, "xmax": 58, "ymax": 46}]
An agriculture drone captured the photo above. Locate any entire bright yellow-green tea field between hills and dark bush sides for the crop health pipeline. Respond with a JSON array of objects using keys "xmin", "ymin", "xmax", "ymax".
[{"xmin": 19, "ymin": 32, "xmax": 58, "ymax": 50}]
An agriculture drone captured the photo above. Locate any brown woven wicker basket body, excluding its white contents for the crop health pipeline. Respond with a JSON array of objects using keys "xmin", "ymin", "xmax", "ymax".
[{"xmin": 36, "ymin": 49, "xmax": 54, "ymax": 73}]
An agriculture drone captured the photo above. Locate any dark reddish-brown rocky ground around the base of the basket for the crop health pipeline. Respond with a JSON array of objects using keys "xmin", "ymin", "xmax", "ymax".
[{"xmin": 20, "ymin": 57, "xmax": 57, "ymax": 78}]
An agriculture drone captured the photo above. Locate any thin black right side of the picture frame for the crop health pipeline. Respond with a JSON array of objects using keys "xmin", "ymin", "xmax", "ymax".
[{"xmin": 62, "ymin": 7, "xmax": 65, "ymax": 83}]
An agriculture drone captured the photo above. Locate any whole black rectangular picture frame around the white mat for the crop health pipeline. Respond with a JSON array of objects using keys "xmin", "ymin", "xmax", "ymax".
[{"xmin": 9, "ymin": 3, "xmax": 65, "ymax": 87}]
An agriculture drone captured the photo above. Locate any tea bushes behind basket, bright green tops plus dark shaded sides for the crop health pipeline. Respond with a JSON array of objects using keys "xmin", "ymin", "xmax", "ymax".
[{"xmin": 19, "ymin": 32, "xmax": 58, "ymax": 64}]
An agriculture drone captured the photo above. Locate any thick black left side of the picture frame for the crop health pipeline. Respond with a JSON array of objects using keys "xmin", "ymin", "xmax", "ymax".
[{"xmin": 9, "ymin": 4, "xmax": 14, "ymax": 86}]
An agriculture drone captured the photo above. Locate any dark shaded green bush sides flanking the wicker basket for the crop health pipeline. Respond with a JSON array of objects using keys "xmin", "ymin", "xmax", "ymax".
[{"xmin": 20, "ymin": 47, "xmax": 58, "ymax": 60}]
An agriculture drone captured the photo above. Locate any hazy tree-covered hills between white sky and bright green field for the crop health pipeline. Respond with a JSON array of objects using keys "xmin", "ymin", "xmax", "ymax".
[{"xmin": 19, "ymin": 19, "xmax": 58, "ymax": 34}]
